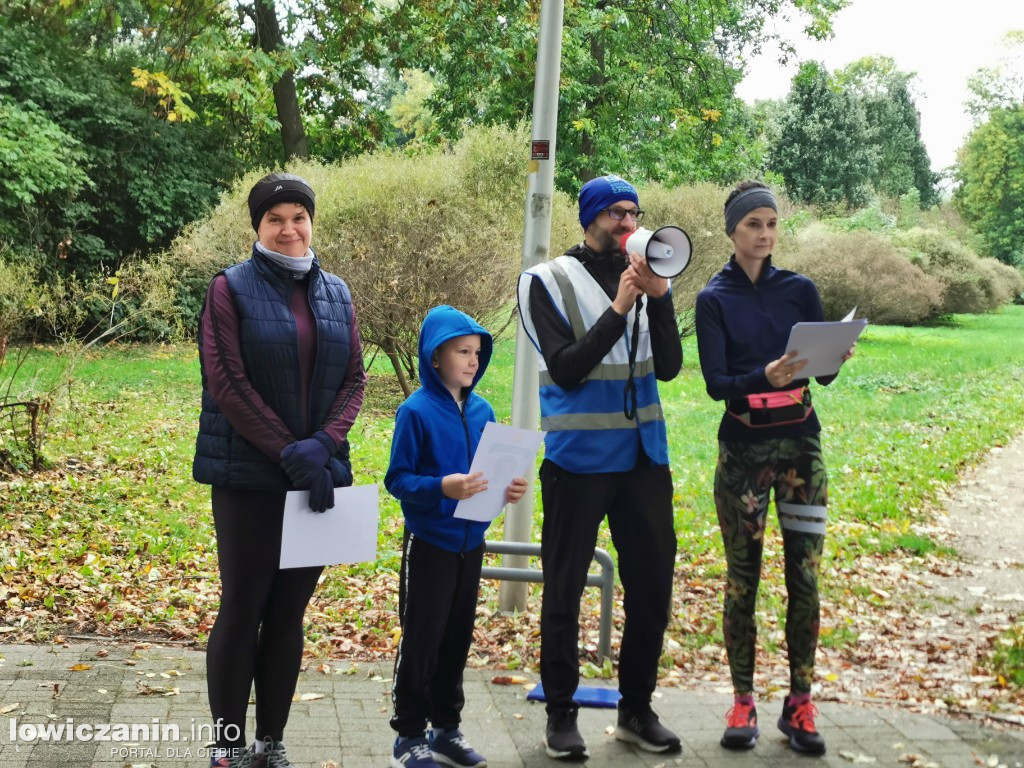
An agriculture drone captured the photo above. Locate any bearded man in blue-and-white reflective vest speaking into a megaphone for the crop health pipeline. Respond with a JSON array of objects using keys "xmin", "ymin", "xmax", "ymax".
[{"xmin": 518, "ymin": 176, "xmax": 689, "ymax": 760}]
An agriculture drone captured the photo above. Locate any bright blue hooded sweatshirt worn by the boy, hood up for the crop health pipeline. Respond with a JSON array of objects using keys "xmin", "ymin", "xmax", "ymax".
[{"xmin": 384, "ymin": 305, "xmax": 495, "ymax": 552}]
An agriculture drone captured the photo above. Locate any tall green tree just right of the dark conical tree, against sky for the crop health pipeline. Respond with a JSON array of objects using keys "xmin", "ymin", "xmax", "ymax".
[{"xmin": 836, "ymin": 56, "xmax": 939, "ymax": 208}]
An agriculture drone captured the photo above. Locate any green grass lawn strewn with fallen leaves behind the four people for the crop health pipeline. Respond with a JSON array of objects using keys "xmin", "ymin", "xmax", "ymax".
[{"xmin": 0, "ymin": 306, "xmax": 1024, "ymax": 679}]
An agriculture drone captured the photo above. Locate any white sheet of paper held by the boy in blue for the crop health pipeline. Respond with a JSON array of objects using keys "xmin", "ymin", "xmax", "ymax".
[{"xmin": 455, "ymin": 422, "xmax": 544, "ymax": 521}]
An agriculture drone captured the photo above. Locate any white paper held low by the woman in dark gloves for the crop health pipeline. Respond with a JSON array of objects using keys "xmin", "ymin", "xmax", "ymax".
[{"xmin": 281, "ymin": 485, "xmax": 379, "ymax": 568}]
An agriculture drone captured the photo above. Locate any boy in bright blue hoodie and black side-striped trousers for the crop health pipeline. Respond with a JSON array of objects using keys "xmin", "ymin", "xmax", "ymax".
[{"xmin": 384, "ymin": 306, "xmax": 526, "ymax": 768}]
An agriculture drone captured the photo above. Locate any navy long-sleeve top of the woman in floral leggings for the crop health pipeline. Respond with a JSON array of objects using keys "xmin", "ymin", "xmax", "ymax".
[{"xmin": 696, "ymin": 256, "xmax": 836, "ymax": 440}]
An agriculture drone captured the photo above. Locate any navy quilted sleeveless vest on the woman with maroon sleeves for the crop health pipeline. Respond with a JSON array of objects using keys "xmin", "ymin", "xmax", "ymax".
[{"xmin": 193, "ymin": 251, "xmax": 352, "ymax": 490}]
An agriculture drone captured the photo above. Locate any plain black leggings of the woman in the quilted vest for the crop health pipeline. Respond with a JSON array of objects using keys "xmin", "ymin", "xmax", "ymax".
[{"xmin": 206, "ymin": 487, "xmax": 321, "ymax": 750}]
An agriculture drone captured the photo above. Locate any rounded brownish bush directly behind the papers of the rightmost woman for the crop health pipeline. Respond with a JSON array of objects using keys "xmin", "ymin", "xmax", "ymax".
[{"xmin": 778, "ymin": 226, "xmax": 944, "ymax": 325}]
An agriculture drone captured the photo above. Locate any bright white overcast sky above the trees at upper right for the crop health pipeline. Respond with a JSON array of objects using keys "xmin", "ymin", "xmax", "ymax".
[{"xmin": 737, "ymin": 0, "xmax": 1024, "ymax": 170}]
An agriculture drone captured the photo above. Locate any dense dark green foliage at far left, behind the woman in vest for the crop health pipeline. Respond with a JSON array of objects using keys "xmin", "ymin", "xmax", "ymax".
[{"xmin": 0, "ymin": 22, "xmax": 236, "ymax": 273}]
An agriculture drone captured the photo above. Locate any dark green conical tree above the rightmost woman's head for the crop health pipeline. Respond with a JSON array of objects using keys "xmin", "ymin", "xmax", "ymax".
[{"xmin": 769, "ymin": 61, "xmax": 877, "ymax": 206}]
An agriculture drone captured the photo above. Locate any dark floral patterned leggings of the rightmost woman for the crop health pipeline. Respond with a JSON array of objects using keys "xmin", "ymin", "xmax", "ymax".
[{"xmin": 715, "ymin": 435, "xmax": 828, "ymax": 695}]
